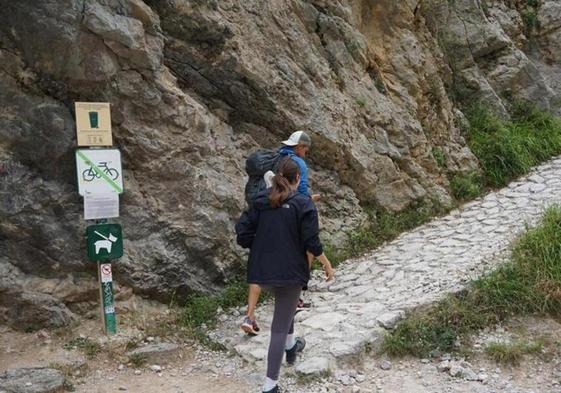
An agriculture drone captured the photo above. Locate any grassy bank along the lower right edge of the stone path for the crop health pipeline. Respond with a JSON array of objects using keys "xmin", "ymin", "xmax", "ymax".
[{"xmin": 383, "ymin": 206, "xmax": 561, "ymax": 358}]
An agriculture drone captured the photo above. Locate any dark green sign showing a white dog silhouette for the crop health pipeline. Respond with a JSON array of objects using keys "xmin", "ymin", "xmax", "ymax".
[{"xmin": 86, "ymin": 224, "xmax": 123, "ymax": 261}]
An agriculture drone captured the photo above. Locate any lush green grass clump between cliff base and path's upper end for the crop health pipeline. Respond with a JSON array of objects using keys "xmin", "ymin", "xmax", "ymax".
[{"xmin": 467, "ymin": 102, "xmax": 561, "ymax": 188}]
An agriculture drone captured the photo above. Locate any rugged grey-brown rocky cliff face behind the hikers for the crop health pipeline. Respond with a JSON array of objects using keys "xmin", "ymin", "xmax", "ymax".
[{"xmin": 0, "ymin": 0, "xmax": 561, "ymax": 328}]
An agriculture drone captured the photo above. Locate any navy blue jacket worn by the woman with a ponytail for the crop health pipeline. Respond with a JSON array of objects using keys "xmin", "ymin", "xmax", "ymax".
[{"xmin": 236, "ymin": 190, "xmax": 323, "ymax": 286}]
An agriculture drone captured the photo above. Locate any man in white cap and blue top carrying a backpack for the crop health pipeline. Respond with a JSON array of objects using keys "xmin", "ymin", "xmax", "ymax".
[{"xmin": 240, "ymin": 131, "xmax": 320, "ymax": 336}]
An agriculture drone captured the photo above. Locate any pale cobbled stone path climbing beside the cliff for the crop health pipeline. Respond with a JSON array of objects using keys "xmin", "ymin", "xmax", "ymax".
[{"xmin": 211, "ymin": 158, "xmax": 561, "ymax": 374}]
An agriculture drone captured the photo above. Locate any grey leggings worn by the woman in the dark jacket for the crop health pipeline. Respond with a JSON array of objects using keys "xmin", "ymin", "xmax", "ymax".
[{"xmin": 267, "ymin": 285, "xmax": 302, "ymax": 381}]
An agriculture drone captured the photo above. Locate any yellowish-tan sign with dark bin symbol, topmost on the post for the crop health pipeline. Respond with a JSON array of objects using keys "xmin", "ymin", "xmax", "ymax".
[{"xmin": 75, "ymin": 102, "xmax": 113, "ymax": 146}]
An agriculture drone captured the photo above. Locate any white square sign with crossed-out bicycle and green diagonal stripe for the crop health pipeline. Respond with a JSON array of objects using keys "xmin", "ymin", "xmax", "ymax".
[{"xmin": 76, "ymin": 149, "xmax": 123, "ymax": 196}]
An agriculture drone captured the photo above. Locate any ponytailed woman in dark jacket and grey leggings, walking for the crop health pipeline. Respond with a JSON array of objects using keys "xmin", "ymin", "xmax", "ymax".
[{"xmin": 236, "ymin": 159, "xmax": 334, "ymax": 393}]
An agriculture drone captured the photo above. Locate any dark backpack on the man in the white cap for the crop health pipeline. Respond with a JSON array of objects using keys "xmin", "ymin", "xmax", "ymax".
[{"xmin": 245, "ymin": 149, "xmax": 283, "ymax": 205}]
